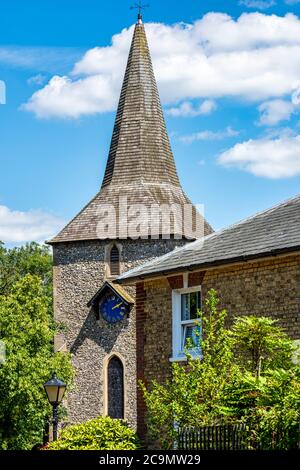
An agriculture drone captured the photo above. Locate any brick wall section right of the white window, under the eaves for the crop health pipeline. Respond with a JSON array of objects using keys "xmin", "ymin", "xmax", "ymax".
[{"xmin": 203, "ymin": 255, "xmax": 300, "ymax": 338}]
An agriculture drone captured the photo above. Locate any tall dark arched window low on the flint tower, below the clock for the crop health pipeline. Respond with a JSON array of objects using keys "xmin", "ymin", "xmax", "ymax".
[{"xmin": 107, "ymin": 356, "xmax": 124, "ymax": 419}]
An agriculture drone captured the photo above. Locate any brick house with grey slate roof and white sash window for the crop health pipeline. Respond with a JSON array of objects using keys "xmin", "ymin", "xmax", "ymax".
[{"xmin": 117, "ymin": 196, "xmax": 300, "ymax": 435}]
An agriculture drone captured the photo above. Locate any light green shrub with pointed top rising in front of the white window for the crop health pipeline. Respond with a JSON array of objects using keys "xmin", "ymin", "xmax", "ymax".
[{"xmin": 141, "ymin": 290, "xmax": 239, "ymax": 448}]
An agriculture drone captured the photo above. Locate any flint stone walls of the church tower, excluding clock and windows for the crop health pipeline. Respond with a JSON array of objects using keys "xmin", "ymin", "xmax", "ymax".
[{"xmin": 54, "ymin": 240, "xmax": 185, "ymax": 426}]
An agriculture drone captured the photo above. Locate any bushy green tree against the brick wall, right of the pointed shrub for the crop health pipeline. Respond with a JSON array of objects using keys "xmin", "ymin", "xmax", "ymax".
[{"xmin": 228, "ymin": 316, "xmax": 300, "ymax": 449}]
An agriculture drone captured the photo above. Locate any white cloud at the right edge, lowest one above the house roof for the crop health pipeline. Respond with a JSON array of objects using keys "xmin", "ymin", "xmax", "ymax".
[{"xmin": 218, "ymin": 135, "xmax": 300, "ymax": 179}]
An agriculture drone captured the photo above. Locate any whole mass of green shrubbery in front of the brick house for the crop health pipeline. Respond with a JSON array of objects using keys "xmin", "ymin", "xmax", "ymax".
[{"xmin": 141, "ymin": 290, "xmax": 300, "ymax": 449}]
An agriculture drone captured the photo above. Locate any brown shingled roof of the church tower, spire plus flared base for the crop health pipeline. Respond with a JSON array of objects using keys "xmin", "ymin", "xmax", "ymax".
[{"xmin": 50, "ymin": 16, "xmax": 212, "ymax": 243}]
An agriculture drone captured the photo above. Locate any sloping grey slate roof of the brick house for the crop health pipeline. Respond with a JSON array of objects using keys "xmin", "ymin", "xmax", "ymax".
[{"xmin": 117, "ymin": 196, "xmax": 300, "ymax": 283}]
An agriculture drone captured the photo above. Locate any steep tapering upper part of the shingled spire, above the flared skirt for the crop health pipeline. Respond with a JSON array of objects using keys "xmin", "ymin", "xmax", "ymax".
[{"xmin": 102, "ymin": 18, "xmax": 180, "ymax": 187}]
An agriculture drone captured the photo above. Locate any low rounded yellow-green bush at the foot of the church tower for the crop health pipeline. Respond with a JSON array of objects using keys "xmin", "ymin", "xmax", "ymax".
[{"xmin": 47, "ymin": 417, "xmax": 139, "ymax": 450}]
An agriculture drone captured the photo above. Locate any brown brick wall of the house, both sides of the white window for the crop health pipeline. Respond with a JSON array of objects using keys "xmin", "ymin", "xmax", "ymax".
[{"xmin": 137, "ymin": 254, "xmax": 300, "ymax": 438}]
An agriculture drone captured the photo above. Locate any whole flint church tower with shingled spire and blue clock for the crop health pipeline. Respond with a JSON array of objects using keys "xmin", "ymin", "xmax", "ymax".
[{"xmin": 49, "ymin": 14, "xmax": 212, "ymax": 426}]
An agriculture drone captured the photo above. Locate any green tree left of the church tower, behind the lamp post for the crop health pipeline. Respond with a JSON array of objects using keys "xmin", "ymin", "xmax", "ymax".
[{"xmin": 0, "ymin": 276, "xmax": 73, "ymax": 450}]
